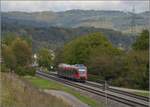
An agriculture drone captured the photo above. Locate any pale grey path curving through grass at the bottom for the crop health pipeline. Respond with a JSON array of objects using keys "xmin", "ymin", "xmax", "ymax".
[{"xmin": 44, "ymin": 90, "xmax": 89, "ymax": 107}]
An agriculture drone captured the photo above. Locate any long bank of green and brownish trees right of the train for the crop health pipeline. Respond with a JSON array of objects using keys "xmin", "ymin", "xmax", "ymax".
[{"xmin": 55, "ymin": 30, "xmax": 149, "ymax": 90}]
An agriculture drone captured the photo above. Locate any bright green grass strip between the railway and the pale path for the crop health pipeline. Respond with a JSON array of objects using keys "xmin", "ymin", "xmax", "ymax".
[{"xmin": 25, "ymin": 76, "xmax": 104, "ymax": 107}]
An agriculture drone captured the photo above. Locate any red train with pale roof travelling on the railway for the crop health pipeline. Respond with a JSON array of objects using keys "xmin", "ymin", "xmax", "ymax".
[{"xmin": 57, "ymin": 64, "xmax": 87, "ymax": 82}]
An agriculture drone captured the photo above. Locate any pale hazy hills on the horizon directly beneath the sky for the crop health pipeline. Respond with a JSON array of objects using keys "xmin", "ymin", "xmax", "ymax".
[{"xmin": 2, "ymin": 10, "xmax": 150, "ymax": 32}]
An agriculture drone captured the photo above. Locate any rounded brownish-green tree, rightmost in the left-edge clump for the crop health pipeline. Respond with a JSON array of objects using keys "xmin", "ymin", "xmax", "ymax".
[{"xmin": 12, "ymin": 38, "xmax": 32, "ymax": 66}]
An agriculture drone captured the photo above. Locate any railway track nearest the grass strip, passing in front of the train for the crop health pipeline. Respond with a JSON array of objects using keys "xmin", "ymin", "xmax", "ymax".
[{"xmin": 37, "ymin": 71, "xmax": 149, "ymax": 107}]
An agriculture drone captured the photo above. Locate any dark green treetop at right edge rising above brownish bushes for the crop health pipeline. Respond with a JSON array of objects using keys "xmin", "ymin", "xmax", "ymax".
[{"xmin": 132, "ymin": 30, "xmax": 149, "ymax": 50}]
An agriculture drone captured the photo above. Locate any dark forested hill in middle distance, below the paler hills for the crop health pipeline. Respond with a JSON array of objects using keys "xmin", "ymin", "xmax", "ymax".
[{"xmin": 2, "ymin": 15, "xmax": 135, "ymax": 50}]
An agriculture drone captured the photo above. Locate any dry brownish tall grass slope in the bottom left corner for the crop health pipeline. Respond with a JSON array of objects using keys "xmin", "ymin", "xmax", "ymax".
[{"xmin": 0, "ymin": 72, "xmax": 71, "ymax": 107}]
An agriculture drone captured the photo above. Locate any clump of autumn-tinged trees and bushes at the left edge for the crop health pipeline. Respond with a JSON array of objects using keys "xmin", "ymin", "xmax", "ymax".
[{"xmin": 1, "ymin": 34, "xmax": 35, "ymax": 75}]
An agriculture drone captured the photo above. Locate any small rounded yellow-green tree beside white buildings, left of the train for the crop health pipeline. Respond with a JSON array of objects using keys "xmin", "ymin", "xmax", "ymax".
[{"xmin": 37, "ymin": 48, "xmax": 53, "ymax": 69}]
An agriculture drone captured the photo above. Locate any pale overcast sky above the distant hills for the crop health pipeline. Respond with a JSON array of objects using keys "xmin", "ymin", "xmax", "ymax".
[{"xmin": 1, "ymin": 0, "xmax": 149, "ymax": 13}]
